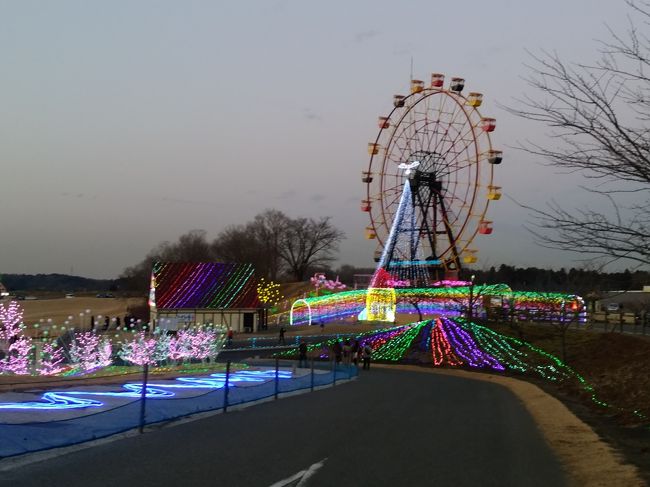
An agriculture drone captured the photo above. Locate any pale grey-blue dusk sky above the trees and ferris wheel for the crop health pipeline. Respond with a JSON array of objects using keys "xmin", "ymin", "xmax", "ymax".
[{"xmin": 0, "ymin": 0, "xmax": 629, "ymax": 278}]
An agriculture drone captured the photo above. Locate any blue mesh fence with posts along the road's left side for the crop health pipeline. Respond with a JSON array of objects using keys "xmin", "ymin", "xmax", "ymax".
[{"xmin": 0, "ymin": 363, "xmax": 358, "ymax": 458}]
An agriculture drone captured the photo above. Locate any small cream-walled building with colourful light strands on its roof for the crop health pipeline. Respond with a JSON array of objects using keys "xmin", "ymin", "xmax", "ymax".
[{"xmin": 149, "ymin": 262, "xmax": 264, "ymax": 332}]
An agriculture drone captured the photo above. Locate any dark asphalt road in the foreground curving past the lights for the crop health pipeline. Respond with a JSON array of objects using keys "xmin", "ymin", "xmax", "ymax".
[{"xmin": 0, "ymin": 369, "xmax": 566, "ymax": 487}]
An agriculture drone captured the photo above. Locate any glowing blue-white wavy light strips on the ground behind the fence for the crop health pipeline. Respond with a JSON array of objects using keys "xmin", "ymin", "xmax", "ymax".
[{"xmin": 0, "ymin": 369, "xmax": 293, "ymax": 410}]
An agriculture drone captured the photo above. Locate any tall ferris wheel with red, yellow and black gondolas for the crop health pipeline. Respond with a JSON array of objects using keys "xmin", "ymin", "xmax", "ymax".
[{"xmin": 361, "ymin": 73, "xmax": 502, "ymax": 276}]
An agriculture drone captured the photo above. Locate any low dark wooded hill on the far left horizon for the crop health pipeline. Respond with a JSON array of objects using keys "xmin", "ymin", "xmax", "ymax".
[{"xmin": 0, "ymin": 274, "xmax": 119, "ymax": 293}]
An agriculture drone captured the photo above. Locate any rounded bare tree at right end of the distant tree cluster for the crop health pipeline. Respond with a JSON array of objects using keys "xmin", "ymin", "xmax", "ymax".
[{"xmin": 280, "ymin": 217, "xmax": 344, "ymax": 281}]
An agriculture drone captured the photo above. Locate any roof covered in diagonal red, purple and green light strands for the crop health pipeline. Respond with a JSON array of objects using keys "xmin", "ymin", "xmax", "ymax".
[{"xmin": 152, "ymin": 262, "xmax": 261, "ymax": 310}]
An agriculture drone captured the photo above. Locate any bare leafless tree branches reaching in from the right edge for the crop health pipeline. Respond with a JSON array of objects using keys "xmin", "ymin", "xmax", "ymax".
[{"xmin": 507, "ymin": 1, "xmax": 650, "ymax": 265}]
